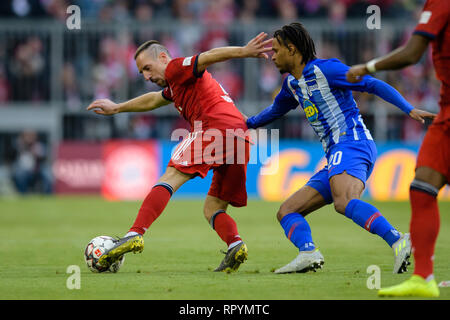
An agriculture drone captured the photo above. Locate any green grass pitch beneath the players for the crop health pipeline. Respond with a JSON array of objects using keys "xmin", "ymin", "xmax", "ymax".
[{"xmin": 0, "ymin": 197, "xmax": 450, "ymax": 300}]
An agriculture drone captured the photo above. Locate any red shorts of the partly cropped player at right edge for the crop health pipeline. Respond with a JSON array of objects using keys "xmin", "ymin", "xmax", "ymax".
[{"xmin": 416, "ymin": 121, "xmax": 450, "ymax": 183}]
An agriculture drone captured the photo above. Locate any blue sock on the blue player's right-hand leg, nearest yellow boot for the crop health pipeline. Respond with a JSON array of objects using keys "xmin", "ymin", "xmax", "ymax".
[{"xmin": 345, "ymin": 199, "xmax": 400, "ymax": 247}]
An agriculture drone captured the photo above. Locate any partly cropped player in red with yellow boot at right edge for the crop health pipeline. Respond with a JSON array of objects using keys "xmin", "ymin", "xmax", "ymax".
[{"xmin": 347, "ymin": 0, "xmax": 450, "ymax": 297}]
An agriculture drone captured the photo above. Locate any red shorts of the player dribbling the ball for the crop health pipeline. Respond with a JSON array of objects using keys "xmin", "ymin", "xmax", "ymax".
[{"xmin": 168, "ymin": 131, "xmax": 250, "ymax": 207}]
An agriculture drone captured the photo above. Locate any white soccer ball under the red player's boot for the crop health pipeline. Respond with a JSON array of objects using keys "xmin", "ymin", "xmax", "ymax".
[{"xmin": 84, "ymin": 236, "xmax": 125, "ymax": 273}]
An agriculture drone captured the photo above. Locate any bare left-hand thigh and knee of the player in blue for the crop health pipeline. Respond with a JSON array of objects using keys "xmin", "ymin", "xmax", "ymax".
[{"xmin": 277, "ymin": 185, "xmax": 327, "ymax": 221}]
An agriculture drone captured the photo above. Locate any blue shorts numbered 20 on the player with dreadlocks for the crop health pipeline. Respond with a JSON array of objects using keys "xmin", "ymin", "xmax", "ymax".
[{"xmin": 306, "ymin": 140, "xmax": 377, "ymax": 203}]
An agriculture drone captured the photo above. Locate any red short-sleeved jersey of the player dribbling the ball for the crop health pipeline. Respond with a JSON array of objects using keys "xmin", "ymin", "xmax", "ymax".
[{"xmin": 162, "ymin": 55, "xmax": 247, "ymax": 136}]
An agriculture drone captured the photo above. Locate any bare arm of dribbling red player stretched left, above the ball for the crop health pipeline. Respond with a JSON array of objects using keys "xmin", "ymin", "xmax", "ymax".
[{"xmin": 86, "ymin": 91, "xmax": 172, "ymax": 116}]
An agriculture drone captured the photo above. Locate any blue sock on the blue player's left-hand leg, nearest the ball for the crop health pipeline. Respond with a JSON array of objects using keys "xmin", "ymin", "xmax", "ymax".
[{"xmin": 280, "ymin": 212, "xmax": 315, "ymax": 251}]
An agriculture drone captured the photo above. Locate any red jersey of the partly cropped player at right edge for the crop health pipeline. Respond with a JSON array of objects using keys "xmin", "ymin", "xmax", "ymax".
[{"xmin": 414, "ymin": 0, "xmax": 450, "ymax": 120}]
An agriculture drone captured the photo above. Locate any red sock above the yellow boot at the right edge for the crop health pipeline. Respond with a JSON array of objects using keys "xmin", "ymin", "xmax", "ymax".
[{"xmin": 409, "ymin": 190, "xmax": 440, "ymax": 279}]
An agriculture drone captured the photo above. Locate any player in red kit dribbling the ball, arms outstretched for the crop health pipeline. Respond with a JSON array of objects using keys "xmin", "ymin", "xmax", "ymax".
[{"xmin": 87, "ymin": 33, "xmax": 271, "ymax": 272}]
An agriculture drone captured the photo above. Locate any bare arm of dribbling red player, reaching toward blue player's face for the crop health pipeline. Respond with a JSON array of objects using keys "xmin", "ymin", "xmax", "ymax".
[{"xmin": 197, "ymin": 32, "xmax": 272, "ymax": 73}]
